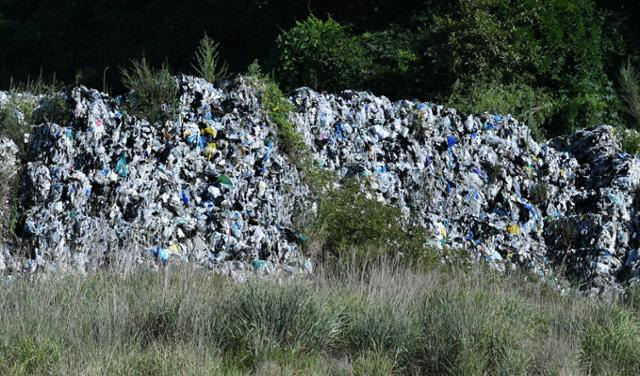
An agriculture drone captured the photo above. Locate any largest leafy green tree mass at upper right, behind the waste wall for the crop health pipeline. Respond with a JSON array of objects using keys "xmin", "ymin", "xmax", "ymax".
[{"xmin": 418, "ymin": 0, "xmax": 617, "ymax": 135}]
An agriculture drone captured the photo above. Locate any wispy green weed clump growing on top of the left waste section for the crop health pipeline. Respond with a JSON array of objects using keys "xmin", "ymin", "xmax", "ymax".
[{"xmin": 121, "ymin": 58, "xmax": 178, "ymax": 122}]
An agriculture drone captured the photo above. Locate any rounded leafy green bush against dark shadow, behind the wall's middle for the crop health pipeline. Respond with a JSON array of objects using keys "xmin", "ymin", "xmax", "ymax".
[{"xmin": 276, "ymin": 16, "xmax": 371, "ymax": 91}]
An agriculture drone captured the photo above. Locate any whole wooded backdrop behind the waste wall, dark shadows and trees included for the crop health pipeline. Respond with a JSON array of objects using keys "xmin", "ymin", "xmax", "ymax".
[{"xmin": 0, "ymin": 0, "xmax": 640, "ymax": 137}]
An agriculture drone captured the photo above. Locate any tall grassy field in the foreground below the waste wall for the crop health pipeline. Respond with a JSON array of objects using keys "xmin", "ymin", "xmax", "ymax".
[{"xmin": 0, "ymin": 264, "xmax": 640, "ymax": 375}]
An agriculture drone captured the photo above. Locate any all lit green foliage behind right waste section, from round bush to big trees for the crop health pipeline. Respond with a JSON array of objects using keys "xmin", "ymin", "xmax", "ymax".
[{"xmin": 273, "ymin": 0, "xmax": 637, "ymax": 139}]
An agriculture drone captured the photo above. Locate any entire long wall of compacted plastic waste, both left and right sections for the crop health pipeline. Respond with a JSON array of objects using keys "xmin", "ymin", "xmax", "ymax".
[{"xmin": 0, "ymin": 76, "xmax": 640, "ymax": 292}]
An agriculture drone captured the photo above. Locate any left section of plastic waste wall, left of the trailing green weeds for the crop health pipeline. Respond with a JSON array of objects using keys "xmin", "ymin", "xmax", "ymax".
[{"xmin": 5, "ymin": 77, "xmax": 307, "ymax": 273}]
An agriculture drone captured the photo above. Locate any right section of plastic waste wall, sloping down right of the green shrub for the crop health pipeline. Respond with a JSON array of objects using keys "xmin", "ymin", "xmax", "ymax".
[{"xmin": 292, "ymin": 89, "xmax": 640, "ymax": 292}]
